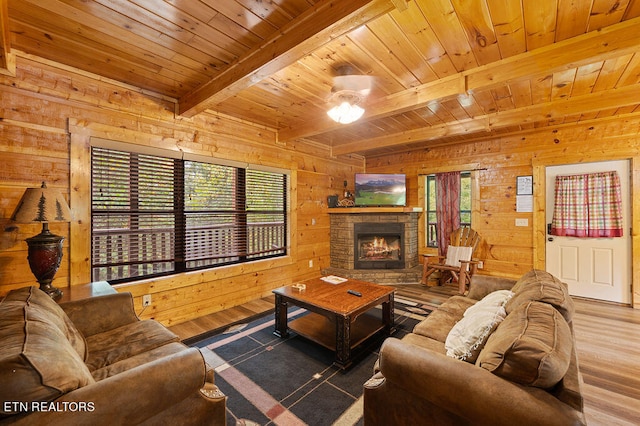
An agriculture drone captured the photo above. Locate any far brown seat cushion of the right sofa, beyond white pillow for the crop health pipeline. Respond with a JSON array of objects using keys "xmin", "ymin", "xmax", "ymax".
[{"xmin": 413, "ymin": 296, "xmax": 477, "ymax": 343}]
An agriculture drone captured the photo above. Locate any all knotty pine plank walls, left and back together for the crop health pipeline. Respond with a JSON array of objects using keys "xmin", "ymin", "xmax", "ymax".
[{"xmin": 0, "ymin": 55, "xmax": 640, "ymax": 325}]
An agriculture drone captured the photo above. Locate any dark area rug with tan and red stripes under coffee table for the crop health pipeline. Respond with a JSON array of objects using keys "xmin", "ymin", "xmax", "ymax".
[{"xmin": 192, "ymin": 299, "xmax": 431, "ymax": 426}]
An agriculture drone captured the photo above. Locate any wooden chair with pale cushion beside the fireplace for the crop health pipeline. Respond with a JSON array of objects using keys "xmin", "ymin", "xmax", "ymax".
[{"xmin": 422, "ymin": 226, "xmax": 480, "ymax": 294}]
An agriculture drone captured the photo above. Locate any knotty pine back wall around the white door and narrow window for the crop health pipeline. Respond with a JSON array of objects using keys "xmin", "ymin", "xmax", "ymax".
[{"xmin": 366, "ymin": 117, "xmax": 640, "ymax": 307}]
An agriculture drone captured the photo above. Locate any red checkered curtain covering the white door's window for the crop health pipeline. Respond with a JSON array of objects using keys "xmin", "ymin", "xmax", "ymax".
[{"xmin": 551, "ymin": 171, "xmax": 622, "ymax": 238}]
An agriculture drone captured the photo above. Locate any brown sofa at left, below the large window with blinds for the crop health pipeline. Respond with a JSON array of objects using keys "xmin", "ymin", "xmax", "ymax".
[{"xmin": 0, "ymin": 287, "xmax": 226, "ymax": 426}]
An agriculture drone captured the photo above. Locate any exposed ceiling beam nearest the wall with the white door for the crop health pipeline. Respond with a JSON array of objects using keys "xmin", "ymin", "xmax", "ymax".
[{"xmin": 331, "ymin": 84, "xmax": 640, "ymax": 157}]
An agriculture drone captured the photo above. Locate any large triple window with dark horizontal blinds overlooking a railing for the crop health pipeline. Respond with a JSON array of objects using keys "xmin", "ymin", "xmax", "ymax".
[{"xmin": 91, "ymin": 147, "xmax": 287, "ymax": 283}]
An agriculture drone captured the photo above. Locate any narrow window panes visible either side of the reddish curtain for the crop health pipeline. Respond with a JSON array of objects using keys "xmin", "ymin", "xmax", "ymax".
[{"xmin": 425, "ymin": 171, "xmax": 471, "ymax": 247}]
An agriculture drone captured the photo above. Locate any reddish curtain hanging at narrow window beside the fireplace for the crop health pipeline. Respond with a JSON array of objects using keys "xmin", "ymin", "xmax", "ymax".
[{"xmin": 436, "ymin": 172, "xmax": 460, "ymax": 256}]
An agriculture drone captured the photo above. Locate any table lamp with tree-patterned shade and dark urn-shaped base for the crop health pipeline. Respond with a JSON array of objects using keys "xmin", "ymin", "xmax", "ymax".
[{"xmin": 11, "ymin": 182, "xmax": 71, "ymax": 299}]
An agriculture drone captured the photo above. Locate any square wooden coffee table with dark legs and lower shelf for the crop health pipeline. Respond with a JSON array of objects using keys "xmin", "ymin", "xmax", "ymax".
[{"xmin": 273, "ymin": 278, "xmax": 395, "ymax": 369}]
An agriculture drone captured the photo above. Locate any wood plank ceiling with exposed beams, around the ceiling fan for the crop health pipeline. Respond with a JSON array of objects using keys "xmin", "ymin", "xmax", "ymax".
[{"xmin": 0, "ymin": 0, "xmax": 640, "ymax": 157}]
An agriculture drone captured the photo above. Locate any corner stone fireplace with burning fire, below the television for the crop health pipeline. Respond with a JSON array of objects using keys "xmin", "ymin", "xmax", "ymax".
[{"xmin": 322, "ymin": 207, "xmax": 422, "ymax": 284}]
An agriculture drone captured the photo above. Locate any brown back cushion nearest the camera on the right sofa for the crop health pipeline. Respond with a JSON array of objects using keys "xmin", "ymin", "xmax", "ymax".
[{"xmin": 476, "ymin": 302, "xmax": 573, "ymax": 389}]
